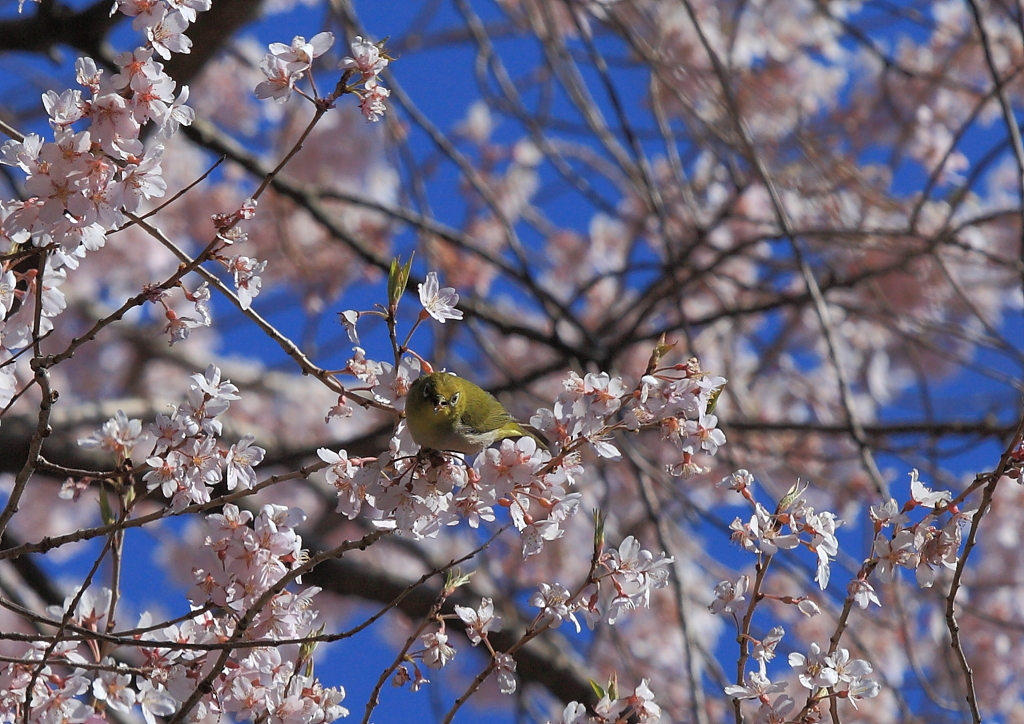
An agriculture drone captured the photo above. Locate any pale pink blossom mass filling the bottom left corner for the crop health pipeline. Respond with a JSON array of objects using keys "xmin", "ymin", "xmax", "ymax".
[{"xmin": 0, "ymin": 504, "xmax": 348, "ymax": 724}]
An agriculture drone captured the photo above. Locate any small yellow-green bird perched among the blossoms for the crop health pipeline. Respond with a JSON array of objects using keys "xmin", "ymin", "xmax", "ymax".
[{"xmin": 406, "ymin": 372, "xmax": 548, "ymax": 454}]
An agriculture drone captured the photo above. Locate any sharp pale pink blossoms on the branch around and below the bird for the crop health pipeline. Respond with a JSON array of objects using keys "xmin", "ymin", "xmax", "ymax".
[{"xmin": 321, "ymin": 272, "xmax": 726, "ymax": 561}]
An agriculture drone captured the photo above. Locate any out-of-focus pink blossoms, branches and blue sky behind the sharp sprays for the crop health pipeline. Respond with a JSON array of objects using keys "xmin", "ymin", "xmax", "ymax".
[{"xmin": 0, "ymin": 0, "xmax": 1024, "ymax": 723}]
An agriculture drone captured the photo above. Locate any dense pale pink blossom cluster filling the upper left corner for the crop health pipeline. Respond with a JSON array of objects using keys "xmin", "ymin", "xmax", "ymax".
[{"xmin": 0, "ymin": 0, "xmax": 209, "ymax": 356}]
